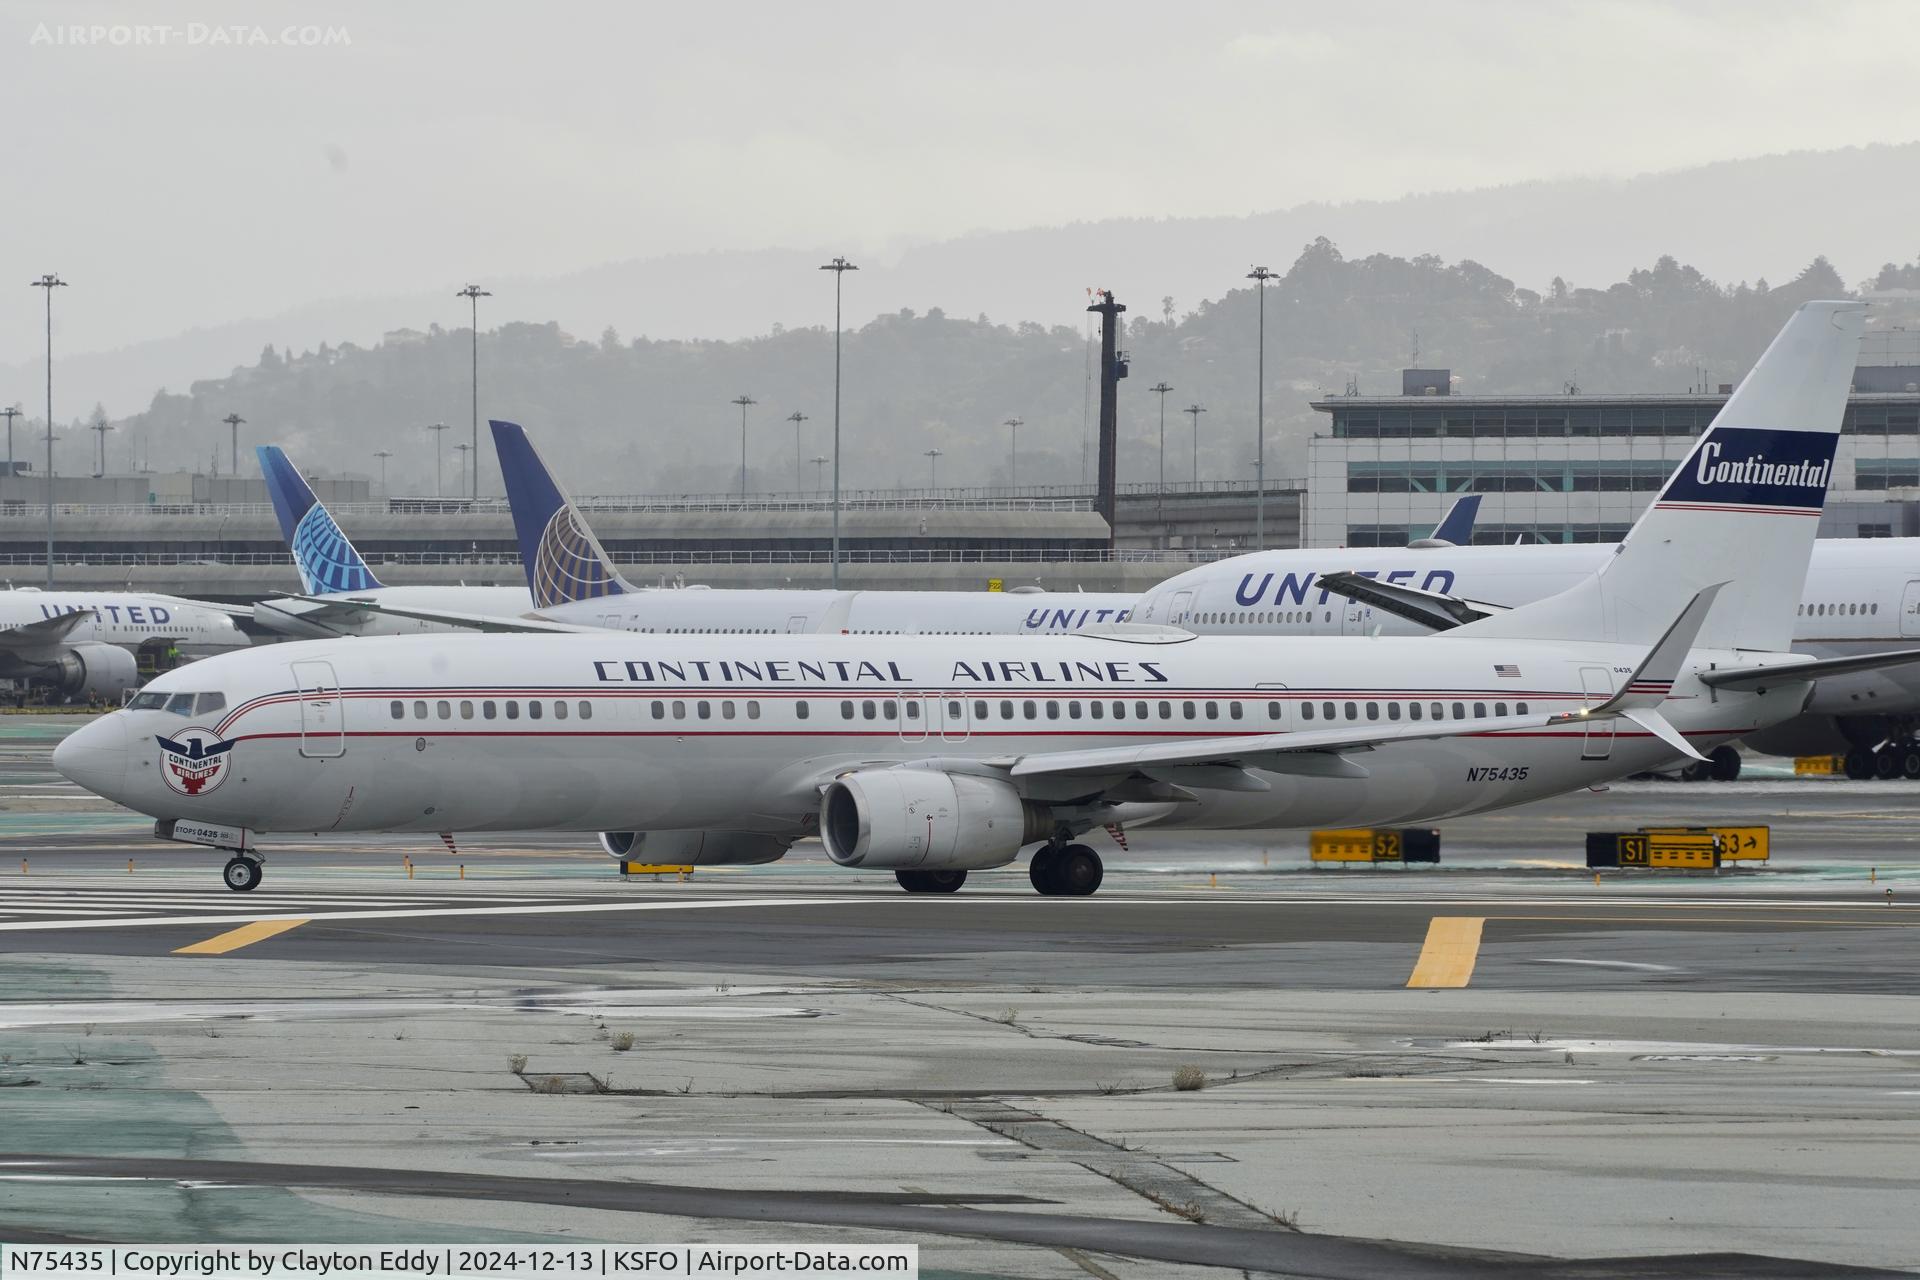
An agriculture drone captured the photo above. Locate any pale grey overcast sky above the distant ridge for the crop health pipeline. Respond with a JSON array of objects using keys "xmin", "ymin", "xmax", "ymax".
[{"xmin": 0, "ymin": 0, "xmax": 1920, "ymax": 364}]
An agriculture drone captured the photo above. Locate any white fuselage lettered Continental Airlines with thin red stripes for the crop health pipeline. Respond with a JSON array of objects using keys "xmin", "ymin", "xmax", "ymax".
[{"xmin": 56, "ymin": 635, "xmax": 1805, "ymax": 835}]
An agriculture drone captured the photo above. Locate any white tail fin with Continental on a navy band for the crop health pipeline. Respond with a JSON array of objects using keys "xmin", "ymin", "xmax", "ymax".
[{"xmin": 1446, "ymin": 301, "xmax": 1866, "ymax": 651}]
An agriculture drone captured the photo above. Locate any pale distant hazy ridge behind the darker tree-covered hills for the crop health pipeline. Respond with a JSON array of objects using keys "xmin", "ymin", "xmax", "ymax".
[{"xmin": 0, "ymin": 142, "xmax": 1920, "ymax": 416}]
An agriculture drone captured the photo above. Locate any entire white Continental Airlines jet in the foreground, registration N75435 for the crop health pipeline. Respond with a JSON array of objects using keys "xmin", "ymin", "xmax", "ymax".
[{"xmin": 54, "ymin": 303, "xmax": 1920, "ymax": 894}]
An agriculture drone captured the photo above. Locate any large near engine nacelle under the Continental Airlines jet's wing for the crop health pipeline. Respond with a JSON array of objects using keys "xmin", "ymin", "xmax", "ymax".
[{"xmin": 820, "ymin": 770, "xmax": 1054, "ymax": 871}]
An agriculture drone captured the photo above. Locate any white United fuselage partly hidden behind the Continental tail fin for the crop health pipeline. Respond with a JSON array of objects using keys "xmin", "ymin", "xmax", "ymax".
[{"xmin": 1135, "ymin": 537, "xmax": 1920, "ymax": 716}]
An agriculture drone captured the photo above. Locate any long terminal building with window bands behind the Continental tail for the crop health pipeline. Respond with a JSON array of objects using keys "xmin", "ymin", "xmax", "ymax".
[{"xmin": 1302, "ymin": 365, "xmax": 1920, "ymax": 547}]
